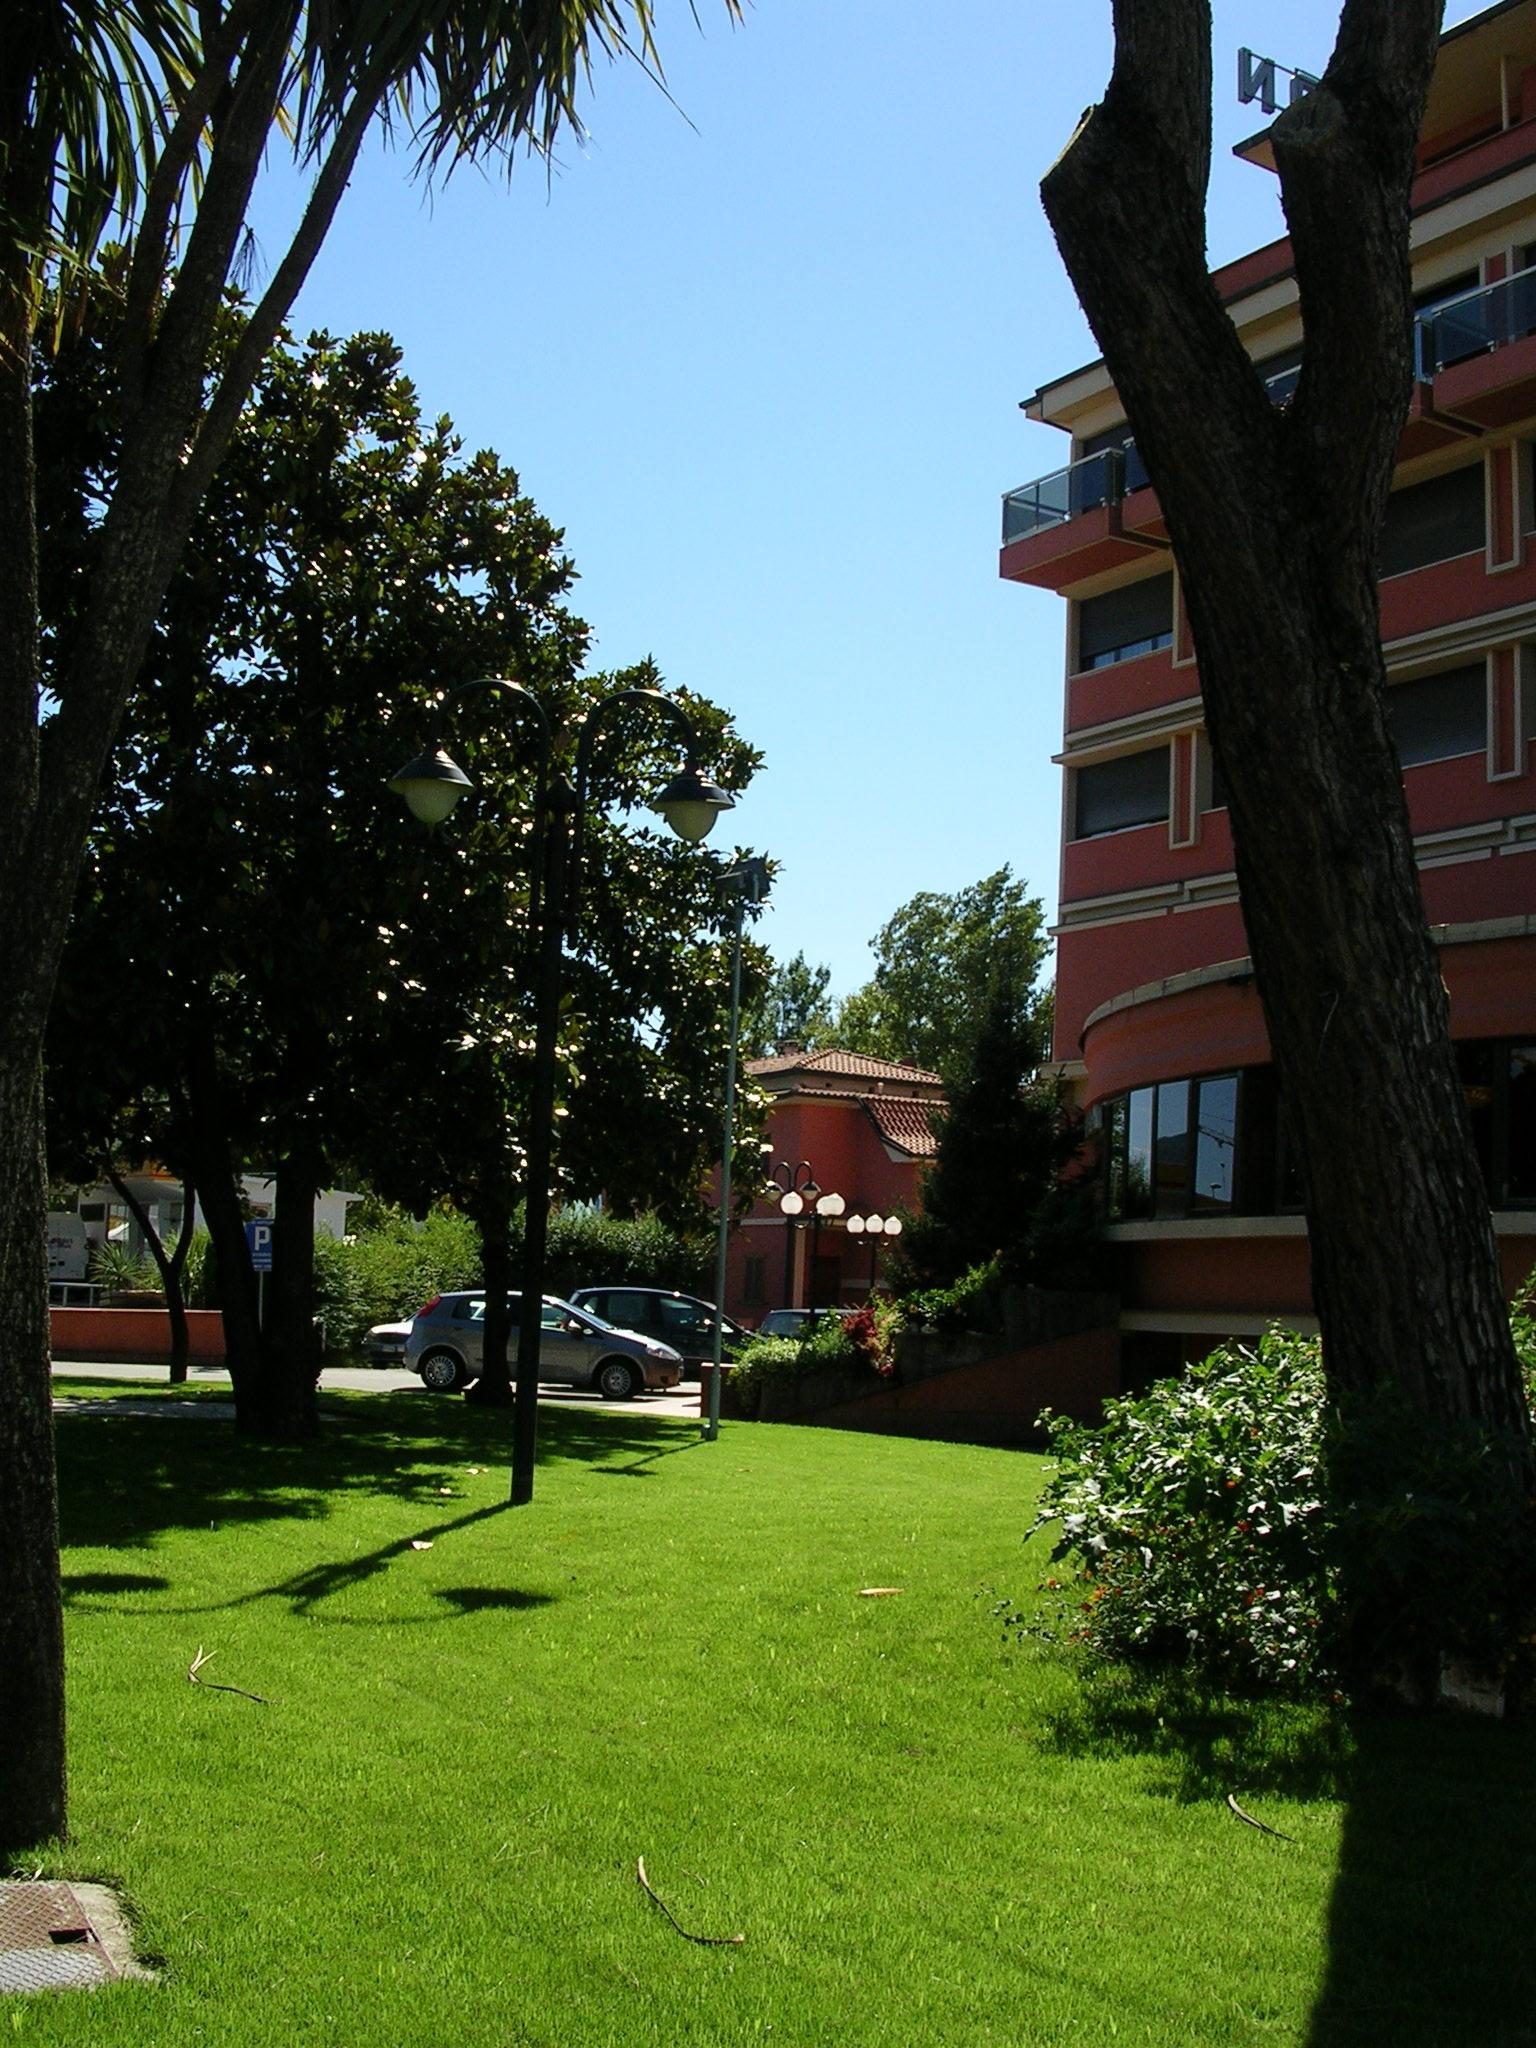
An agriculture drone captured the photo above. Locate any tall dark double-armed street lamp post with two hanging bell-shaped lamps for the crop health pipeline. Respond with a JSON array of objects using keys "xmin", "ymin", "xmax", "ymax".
[{"xmin": 389, "ymin": 676, "xmax": 731, "ymax": 1507}]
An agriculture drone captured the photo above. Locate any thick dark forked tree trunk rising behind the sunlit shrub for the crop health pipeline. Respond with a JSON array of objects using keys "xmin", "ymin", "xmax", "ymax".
[{"xmin": 1042, "ymin": 0, "xmax": 1530, "ymax": 1462}]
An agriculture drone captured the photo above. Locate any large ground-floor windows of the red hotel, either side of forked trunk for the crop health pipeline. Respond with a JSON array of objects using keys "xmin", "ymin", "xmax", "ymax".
[{"xmin": 1090, "ymin": 1038, "xmax": 1536, "ymax": 1223}]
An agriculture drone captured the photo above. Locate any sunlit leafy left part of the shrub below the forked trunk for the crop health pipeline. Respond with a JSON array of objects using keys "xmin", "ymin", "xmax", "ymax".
[{"xmin": 1024, "ymin": 1331, "xmax": 1331, "ymax": 1686}]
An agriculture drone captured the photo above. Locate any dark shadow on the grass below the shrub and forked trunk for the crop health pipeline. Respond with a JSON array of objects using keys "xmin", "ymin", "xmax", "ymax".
[{"xmin": 1044, "ymin": 1667, "xmax": 1536, "ymax": 2048}]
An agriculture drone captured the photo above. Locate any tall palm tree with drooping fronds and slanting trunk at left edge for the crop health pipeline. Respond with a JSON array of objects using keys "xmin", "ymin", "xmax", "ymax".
[{"xmin": 0, "ymin": 0, "xmax": 741, "ymax": 1853}]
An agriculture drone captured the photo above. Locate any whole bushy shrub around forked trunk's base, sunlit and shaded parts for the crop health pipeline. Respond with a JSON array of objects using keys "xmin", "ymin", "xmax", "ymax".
[{"xmin": 1015, "ymin": 1329, "xmax": 1536, "ymax": 1696}]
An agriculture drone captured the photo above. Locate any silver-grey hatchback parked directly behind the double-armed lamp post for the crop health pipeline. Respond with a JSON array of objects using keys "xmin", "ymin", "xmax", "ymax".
[{"xmin": 406, "ymin": 1290, "xmax": 682, "ymax": 1401}]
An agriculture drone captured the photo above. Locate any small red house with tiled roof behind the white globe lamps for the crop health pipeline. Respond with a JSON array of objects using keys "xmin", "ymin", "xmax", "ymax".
[{"xmin": 725, "ymin": 1042, "xmax": 944, "ymax": 1323}]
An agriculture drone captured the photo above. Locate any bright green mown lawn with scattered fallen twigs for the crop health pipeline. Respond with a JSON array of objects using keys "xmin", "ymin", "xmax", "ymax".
[{"xmin": 12, "ymin": 1384, "xmax": 1536, "ymax": 2048}]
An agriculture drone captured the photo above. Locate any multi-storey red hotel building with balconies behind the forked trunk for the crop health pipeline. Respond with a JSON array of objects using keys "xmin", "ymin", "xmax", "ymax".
[{"xmin": 1001, "ymin": 0, "xmax": 1536, "ymax": 1384}]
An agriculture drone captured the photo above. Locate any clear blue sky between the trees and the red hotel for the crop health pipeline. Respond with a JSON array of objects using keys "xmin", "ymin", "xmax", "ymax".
[{"xmin": 258, "ymin": 0, "xmax": 1479, "ymax": 993}]
